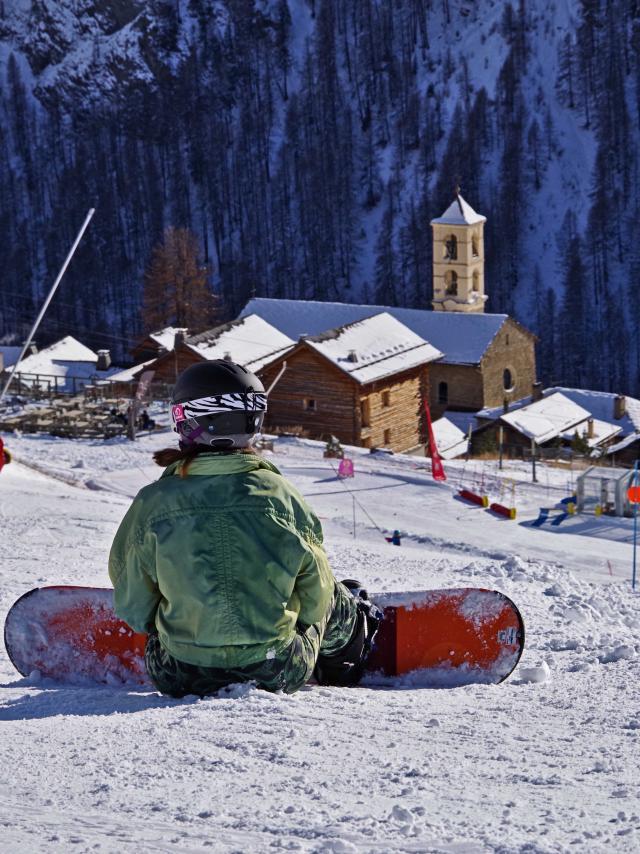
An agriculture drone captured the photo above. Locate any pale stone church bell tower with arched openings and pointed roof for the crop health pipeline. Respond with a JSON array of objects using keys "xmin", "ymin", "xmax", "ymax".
[{"xmin": 431, "ymin": 187, "xmax": 487, "ymax": 313}]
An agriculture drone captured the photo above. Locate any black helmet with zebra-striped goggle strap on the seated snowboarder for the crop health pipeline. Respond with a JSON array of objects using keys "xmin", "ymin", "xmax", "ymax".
[{"xmin": 171, "ymin": 359, "xmax": 267, "ymax": 450}]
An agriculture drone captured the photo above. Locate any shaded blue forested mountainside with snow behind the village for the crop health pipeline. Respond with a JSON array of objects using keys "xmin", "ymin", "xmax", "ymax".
[{"xmin": 0, "ymin": 0, "xmax": 640, "ymax": 392}]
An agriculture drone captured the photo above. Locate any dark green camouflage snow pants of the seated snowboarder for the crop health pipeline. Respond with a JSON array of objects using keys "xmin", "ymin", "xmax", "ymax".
[{"xmin": 145, "ymin": 581, "xmax": 358, "ymax": 697}]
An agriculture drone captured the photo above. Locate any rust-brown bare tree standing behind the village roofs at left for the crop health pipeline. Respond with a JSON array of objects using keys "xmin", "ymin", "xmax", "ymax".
[{"xmin": 142, "ymin": 228, "xmax": 217, "ymax": 333}]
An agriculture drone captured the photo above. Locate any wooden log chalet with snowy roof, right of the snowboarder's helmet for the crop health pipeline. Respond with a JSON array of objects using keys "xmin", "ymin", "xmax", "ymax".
[{"xmin": 259, "ymin": 312, "xmax": 441, "ymax": 451}]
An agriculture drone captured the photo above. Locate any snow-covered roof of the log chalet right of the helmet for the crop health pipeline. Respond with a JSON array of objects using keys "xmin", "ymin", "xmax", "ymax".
[{"xmin": 305, "ymin": 312, "xmax": 441, "ymax": 383}]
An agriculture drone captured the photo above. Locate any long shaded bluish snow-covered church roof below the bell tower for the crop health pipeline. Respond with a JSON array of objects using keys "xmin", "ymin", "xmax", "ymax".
[{"xmin": 240, "ymin": 297, "xmax": 508, "ymax": 365}]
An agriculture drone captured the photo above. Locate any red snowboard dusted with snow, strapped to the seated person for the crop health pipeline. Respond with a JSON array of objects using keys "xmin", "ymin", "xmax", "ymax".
[{"xmin": 4, "ymin": 586, "xmax": 524, "ymax": 686}]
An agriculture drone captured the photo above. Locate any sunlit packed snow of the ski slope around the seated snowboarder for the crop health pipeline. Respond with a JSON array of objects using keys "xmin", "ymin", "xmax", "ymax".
[{"xmin": 0, "ymin": 433, "xmax": 640, "ymax": 854}]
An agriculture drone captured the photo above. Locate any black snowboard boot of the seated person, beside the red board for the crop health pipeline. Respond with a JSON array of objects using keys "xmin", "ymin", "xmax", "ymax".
[{"xmin": 315, "ymin": 579, "xmax": 382, "ymax": 686}]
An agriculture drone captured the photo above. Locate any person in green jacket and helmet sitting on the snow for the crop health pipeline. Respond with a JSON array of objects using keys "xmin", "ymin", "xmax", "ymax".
[{"xmin": 109, "ymin": 360, "xmax": 379, "ymax": 697}]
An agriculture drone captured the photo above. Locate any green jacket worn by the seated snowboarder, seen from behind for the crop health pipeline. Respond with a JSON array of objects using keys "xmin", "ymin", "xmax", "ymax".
[{"xmin": 109, "ymin": 453, "xmax": 334, "ymax": 668}]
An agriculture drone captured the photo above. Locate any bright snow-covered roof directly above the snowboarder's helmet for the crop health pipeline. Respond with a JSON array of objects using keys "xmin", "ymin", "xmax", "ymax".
[{"xmin": 185, "ymin": 314, "xmax": 295, "ymax": 371}]
